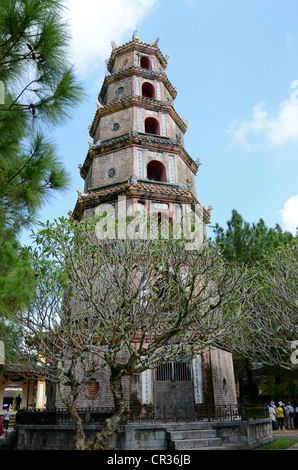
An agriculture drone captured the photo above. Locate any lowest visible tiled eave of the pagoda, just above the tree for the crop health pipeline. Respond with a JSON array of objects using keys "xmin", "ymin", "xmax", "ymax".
[{"xmin": 72, "ymin": 180, "xmax": 210, "ymax": 223}]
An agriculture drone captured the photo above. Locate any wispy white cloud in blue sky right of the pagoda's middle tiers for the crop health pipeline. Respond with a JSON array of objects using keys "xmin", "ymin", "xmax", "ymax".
[{"xmin": 230, "ymin": 81, "xmax": 298, "ymax": 148}]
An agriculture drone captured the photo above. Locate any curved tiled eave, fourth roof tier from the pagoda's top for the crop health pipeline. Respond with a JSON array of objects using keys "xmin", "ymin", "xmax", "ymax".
[{"xmin": 80, "ymin": 131, "xmax": 199, "ymax": 179}]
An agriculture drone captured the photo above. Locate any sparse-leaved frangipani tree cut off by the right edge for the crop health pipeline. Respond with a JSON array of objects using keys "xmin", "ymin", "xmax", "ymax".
[{"xmin": 233, "ymin": 240, "xmax": 298, "ymax": 369}]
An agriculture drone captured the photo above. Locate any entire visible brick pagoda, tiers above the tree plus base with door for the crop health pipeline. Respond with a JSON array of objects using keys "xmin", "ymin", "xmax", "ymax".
[{"xmin": 66, "ymin": 34, "xmax": 237, "ymax": 414}]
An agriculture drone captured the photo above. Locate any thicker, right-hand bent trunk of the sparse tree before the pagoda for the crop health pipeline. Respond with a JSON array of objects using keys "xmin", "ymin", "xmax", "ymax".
[{"xmin": 87, "ymin": 367, "xmax": 127, "ymax": 450}]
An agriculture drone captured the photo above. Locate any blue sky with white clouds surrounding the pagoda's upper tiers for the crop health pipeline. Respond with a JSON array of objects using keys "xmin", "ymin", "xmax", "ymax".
[{"xmin": 22, "ymin": 0, "xmax": 298, "ymax": 243}]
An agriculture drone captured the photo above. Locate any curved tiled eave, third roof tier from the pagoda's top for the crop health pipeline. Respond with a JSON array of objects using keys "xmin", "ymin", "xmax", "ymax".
[{"xmin": 89, "ymin": 95, "xmax": 187, "ymax": 138}]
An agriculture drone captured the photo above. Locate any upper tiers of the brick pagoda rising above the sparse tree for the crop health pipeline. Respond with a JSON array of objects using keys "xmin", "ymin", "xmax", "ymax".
[{"xmin": 73, "ymin": 34, "xmax": 210, "ymax": 239}]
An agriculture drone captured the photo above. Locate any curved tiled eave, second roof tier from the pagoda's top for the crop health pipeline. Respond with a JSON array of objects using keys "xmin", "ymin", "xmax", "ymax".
[{"xmin": 98, "ymin": 65, "xmax": 177, "ymax": 102}]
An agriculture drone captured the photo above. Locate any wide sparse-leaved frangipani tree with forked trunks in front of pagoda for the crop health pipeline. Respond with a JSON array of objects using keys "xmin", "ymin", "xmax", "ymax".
[{"xmin": 8, "ymin": 218, "xmax": 253, "ymax": 449}]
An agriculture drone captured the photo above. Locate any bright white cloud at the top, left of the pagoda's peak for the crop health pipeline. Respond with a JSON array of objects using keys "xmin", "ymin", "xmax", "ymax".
[{"xmin": 67, "ymin": 0, "xmax": 157, "ymax": 74}]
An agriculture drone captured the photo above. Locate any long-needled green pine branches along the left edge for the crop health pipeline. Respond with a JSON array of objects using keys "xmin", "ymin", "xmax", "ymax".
[{"xmin": 0, "ymin": 0, "xmax": 84, "ymax": 315}]
